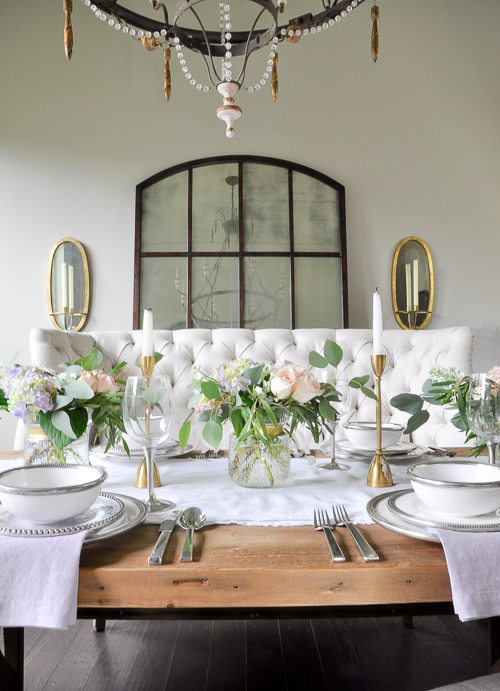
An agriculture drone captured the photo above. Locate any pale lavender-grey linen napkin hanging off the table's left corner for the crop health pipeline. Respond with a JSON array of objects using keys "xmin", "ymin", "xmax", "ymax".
[{"xmin": 0, "ymin": 530, "xmax": 87, "ymax": 629}]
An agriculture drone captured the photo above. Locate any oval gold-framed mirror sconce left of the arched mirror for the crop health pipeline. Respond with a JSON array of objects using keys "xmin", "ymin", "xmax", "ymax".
[{"xmin": 47, "ymin": 238, "xmax": 90, "ymax": 331}]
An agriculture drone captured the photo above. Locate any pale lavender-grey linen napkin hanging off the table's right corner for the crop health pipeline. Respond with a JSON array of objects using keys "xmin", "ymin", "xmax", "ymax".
[{"xmin": 432, "ymin": 528, "xmax": 500, "ymax": 621}]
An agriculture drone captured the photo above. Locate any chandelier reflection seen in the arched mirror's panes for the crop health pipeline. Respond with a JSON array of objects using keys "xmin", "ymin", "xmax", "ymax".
[{"xmin": 174, "ymin": 175, "xmax": 287, "ymax": 329}]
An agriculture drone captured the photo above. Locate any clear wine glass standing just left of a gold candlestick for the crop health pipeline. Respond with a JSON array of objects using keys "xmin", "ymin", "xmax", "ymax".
[{"xmin": 123, "ymin": 375, "xmax": 175, "ymax": 513}]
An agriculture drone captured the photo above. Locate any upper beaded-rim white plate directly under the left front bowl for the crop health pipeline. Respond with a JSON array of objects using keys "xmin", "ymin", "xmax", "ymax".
[{"xmin": 0, "ymin": 492, "xmax": 125, "ymax": 537}]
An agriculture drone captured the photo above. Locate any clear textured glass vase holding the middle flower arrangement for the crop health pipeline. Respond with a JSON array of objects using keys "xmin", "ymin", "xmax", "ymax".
[{"xmin": 228, "ymin": 434, "xmax": 290, "ymax": 488}]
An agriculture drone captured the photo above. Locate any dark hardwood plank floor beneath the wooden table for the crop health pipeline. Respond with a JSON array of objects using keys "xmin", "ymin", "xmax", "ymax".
[{"xmin": 0, "ymin": 616, "xmax": 487, "ymax": 691}]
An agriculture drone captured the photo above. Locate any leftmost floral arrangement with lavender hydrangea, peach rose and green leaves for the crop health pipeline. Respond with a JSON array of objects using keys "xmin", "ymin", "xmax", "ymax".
[{"xmin": 0, "ymin": 348, "xmax": 129, "ymax": 462}]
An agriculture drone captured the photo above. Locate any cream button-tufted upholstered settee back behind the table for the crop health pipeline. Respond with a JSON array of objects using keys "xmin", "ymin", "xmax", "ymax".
[{"xmin": 19, "ymin": 327, "xmax": 473, "ymax": 448}]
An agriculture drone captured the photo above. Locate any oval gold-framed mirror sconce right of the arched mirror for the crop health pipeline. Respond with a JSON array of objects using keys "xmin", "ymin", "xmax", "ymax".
[{"xmin": 392, "ymin": 237, "xmax": 434, "ymax": 329}]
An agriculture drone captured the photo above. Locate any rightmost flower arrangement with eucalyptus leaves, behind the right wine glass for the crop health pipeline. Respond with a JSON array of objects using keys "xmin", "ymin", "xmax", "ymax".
[{"xmin": 391, "ymin": 365, "xmax": 500, "ymax": 456}]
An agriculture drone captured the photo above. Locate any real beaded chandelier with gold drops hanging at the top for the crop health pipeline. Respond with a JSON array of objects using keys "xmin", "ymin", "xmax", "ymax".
[{"xmin": 63, "ymin": 0, "xmax": 379, "ymax": 137}]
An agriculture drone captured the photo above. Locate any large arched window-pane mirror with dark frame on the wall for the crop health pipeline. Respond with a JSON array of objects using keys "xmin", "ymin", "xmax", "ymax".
[{"xmin": 134, "ymin": 156, "xmax": 348, "ymax": 329}]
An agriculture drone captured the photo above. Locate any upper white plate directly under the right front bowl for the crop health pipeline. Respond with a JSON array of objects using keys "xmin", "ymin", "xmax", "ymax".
[{"xmin": 388, "ymin": 489, "xmax": 500, "ymax": 533}]
